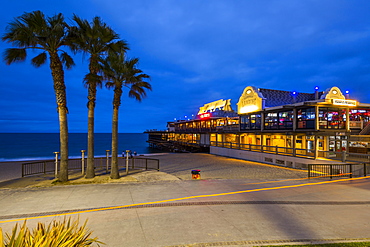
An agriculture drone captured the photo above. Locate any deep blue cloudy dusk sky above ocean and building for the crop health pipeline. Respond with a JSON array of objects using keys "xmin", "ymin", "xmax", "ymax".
[{"xmin": 0, "ymin": 0, "xmax": 370, "ymax": 133}]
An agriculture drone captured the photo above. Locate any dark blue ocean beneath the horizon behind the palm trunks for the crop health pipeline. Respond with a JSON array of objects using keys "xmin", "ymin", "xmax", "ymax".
[{"xmin": 0, "ymin": 133, "xmax": 158, "ymax": 162}]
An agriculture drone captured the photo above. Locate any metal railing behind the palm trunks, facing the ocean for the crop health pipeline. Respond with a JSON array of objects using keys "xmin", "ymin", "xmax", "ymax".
[{"xmin": 22, "ymin": 157, "xmax": 159, "ymax": 177}]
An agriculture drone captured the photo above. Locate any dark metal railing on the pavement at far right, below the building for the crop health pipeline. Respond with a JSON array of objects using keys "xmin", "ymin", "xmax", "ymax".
[{"xmin": 307, "ymin": 163, "xmax": 369, "ymax": 179}]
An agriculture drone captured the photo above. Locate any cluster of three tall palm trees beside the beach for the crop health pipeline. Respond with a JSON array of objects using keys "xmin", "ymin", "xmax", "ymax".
[{"xmin": 2, "ymin": 11, "xmax": 151, "ymax": 182}]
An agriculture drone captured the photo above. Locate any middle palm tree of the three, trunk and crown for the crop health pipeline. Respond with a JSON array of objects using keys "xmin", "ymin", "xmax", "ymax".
[{"xmin": 71, "ymin": 15, "xmax": 128, "ymax": 178}]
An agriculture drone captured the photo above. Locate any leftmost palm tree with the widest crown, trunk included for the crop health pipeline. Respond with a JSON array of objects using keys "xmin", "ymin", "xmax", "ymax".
[{"xmin": 2, "ymin": 11, "xmax": 74, "ymax": 182}]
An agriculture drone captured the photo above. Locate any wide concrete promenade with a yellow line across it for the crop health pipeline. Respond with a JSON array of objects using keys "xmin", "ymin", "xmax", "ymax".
[{"xmin": 0, "ymin": 154, "xmax": 370, "ymax": 246}]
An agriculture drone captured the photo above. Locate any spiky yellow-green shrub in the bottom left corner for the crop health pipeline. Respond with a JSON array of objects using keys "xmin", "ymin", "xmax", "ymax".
[{"xmin": 0, "ymin": 218, "xmax": 103, "ymax": 247}]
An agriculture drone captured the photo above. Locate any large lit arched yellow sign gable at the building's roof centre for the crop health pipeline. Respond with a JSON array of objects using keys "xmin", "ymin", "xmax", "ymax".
[{"xmin": 237, "ymin": 86, "xmax": 263, "ymax": 114}]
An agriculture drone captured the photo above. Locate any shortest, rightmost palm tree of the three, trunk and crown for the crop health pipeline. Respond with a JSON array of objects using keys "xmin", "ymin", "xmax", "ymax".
[{"xmin": 104, "ymin": 53, "xmax": 152, "ymax": 179}]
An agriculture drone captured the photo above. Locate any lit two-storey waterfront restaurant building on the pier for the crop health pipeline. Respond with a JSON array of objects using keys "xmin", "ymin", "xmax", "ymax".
[{"xmin": 147, "ymin": 86, "xmax": 370, "ymax": 167}]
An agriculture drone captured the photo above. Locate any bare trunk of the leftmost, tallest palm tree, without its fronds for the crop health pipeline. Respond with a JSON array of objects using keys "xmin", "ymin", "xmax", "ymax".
[{"xmin": 50, "ymin": 52, "xmax": 68, "ymax": 182}]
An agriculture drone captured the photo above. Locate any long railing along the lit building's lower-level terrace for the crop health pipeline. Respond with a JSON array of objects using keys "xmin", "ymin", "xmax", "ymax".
[{"xmin": 211, "ymin": 141, "xmax": 370, "ymax": 162}]
